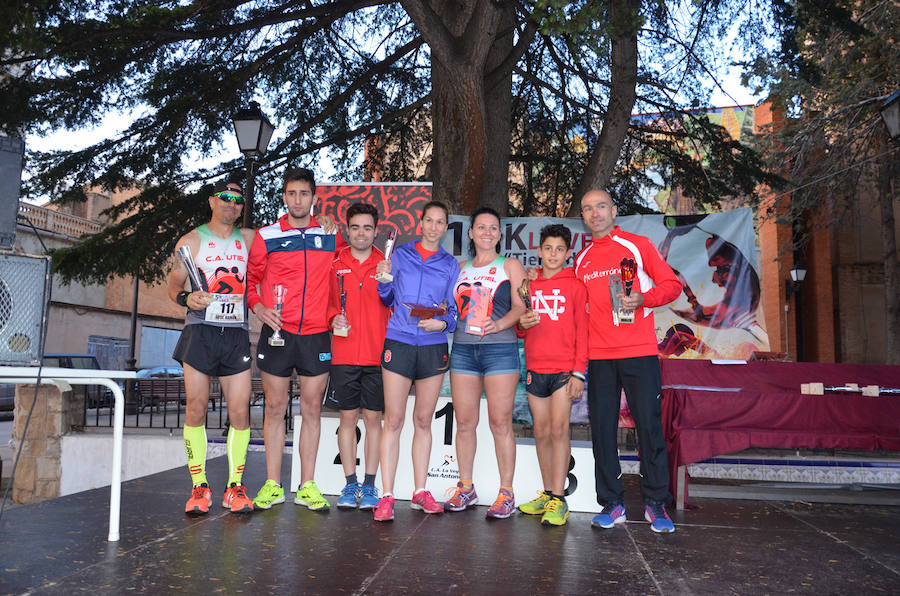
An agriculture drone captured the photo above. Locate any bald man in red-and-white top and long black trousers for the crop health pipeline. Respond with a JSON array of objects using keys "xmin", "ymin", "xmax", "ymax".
[{"xmin": 575, "ymin": 190, "xmax": 681, "ymax": 532}]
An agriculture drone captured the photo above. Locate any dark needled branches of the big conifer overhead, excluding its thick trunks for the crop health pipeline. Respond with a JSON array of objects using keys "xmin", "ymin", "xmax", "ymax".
[{"xmin": 0, "ymin": 0, "xmax": 784, "ymax": 281}]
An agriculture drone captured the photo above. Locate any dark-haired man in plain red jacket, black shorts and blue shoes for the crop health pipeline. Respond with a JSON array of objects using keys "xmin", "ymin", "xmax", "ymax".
[{"xmin": 328, "ymin": 203, "xmax": 390, "ymax": 509}]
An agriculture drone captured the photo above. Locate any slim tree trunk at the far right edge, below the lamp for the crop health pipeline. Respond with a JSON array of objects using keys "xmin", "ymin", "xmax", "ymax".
[{"xmin": 878, "ymin": 148, "xmax": 900, "ymax": 364}]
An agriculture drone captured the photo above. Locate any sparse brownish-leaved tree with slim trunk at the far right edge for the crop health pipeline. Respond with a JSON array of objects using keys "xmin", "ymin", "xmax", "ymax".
[{"xmin": 747, "ymin": 0, "xmax": 900, "ymax": 364}]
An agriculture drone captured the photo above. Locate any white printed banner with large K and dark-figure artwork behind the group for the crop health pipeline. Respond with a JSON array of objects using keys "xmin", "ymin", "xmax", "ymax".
[{"xmin": 442, "ymin": 208, "xmax": 769, "ymax": 360}]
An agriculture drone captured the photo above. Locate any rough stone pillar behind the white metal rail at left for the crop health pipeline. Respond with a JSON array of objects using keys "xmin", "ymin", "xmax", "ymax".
[{"xmin": 12, "ymin": 385, "xmax": 84, "ymax": 503}]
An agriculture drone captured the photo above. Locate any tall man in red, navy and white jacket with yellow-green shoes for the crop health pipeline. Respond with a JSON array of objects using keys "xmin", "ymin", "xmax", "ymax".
[{"xmin": 247, "ymin": 168, "xmax": 346, "ymax": 511}]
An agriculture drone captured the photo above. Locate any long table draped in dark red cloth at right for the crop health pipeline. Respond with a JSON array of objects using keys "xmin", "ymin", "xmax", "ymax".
[{"xmin": 660, "ymin": 359, "xmax": 900, "ymax": 508}]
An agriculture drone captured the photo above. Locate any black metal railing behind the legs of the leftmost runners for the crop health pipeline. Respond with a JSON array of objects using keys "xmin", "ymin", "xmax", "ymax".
[{"xmin": 79, "ymin": 377, "xmax": 300, "ymax": 431}]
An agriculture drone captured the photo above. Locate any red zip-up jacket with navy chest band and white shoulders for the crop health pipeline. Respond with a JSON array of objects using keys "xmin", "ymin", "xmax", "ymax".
[{"xmin": 247, "ymin": 214, "xmax": 347, "ymax": 335}]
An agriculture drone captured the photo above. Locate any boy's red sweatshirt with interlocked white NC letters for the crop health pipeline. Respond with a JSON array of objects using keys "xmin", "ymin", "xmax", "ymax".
[{"xmin": 516, "ymin": 267, "xmax": 588, "ymax": 374}]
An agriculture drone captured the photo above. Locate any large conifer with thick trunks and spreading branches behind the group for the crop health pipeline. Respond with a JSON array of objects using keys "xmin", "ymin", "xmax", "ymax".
[{"xmin": 0, "ymin": 0, "xmax": 764, "ymax": 281}]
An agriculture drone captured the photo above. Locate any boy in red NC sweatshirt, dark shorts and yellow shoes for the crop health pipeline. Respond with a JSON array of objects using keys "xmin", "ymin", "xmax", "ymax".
[{"xmin": 518, "ymin": 224, "xmax": 588, "ymax": 526}]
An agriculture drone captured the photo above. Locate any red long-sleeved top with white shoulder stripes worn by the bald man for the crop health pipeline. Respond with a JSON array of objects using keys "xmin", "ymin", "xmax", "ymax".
[{"xmin": 575, "ymin": 226, "xmax": 681, "ymax": 360}]
